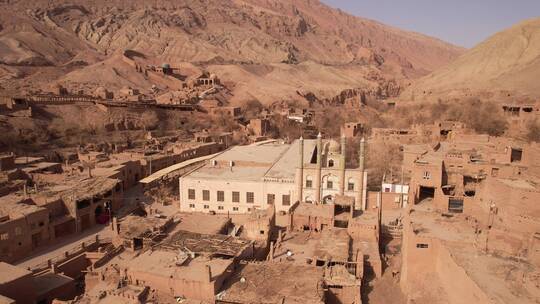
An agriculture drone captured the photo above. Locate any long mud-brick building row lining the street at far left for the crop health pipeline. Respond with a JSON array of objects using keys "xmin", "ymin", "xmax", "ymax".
[{"xmin": 0, "ymin": 177, "xmax": 123, "ymax": 262}]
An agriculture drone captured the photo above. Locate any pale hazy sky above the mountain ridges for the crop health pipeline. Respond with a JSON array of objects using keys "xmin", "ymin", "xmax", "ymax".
[{"xmin": 321, "ymin": 0, "xmax": 540, "ymax": 47}]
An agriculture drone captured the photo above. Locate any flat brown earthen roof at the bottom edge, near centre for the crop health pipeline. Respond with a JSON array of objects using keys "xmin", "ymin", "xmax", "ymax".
[{"xmin": 217, "ymin": 262, "xmax": 324, "ymax": 304}]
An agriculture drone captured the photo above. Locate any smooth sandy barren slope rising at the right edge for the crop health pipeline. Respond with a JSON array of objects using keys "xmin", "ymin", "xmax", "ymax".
[{"xmin": 403, "ymin": 18, "xmax": 540, "ymax": 99}]
